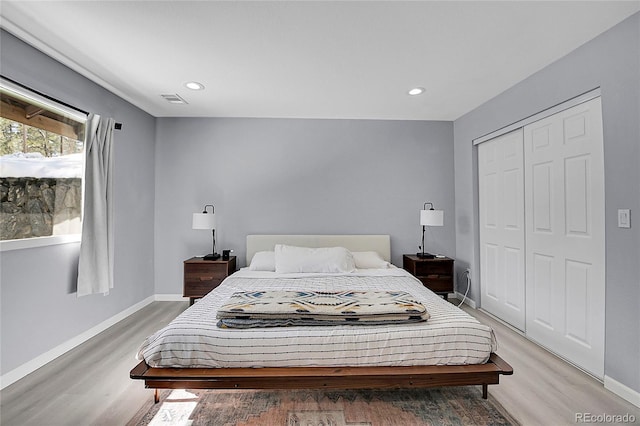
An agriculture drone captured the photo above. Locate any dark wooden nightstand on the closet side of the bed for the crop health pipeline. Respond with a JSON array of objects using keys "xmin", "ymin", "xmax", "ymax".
[{"xmin": 402, "ymin": 254, "xmax": 453, "ymax": 300}]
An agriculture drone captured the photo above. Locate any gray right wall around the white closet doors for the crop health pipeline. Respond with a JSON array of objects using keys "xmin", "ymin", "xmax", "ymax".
[{"xmin": 454, "ymin": 14, "xmax": 640, "ymax": 392}]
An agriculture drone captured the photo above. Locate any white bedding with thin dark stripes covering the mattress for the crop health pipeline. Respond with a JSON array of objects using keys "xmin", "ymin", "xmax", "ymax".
[{"xmin": 137, "ymin": 268, "xmax": 496, "ymax": 368}]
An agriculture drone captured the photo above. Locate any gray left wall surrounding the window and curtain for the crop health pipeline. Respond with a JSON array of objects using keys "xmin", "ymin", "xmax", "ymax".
[{"xmin": 0, "ymin": 31, "xmax": 155, "ymax": 374}]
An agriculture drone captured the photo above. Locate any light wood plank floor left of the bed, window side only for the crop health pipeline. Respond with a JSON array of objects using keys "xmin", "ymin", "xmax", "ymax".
[{"xmin": 0, "ymin": 302, "xmax": 189, "ymax": 426}]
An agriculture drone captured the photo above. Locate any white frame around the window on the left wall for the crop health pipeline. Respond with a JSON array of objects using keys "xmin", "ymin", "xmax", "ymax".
[{"xmin": 0, "ymin": 76, "xmax": 89, "ymax": 253}]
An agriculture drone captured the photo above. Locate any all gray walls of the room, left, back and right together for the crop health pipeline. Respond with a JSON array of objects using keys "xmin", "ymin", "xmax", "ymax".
[{"xmin": 0, "ymin": 9, "xmax": 640, "ymax": 400}]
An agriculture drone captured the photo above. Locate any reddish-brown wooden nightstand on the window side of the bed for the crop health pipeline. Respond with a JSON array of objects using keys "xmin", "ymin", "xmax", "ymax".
[{"xmin": 182, "ymin": 256, "xmax": 236, "ymax": 305}]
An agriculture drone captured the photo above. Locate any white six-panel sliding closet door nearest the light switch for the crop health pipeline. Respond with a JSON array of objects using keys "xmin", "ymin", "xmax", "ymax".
[{"xmin": 524, "ymin": 98, "xmax": 605, "ymax": 378}]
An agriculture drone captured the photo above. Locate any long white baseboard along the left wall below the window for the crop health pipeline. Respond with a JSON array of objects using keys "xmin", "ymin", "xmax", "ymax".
[{"xmin": 0, "ymin": 296, "xmax": 157, "ymax": 389}]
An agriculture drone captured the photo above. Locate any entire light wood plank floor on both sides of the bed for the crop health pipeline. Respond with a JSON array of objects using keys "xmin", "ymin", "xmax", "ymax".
[{"xmin": 0, "ymin": 302, "xmax": 640, "ymax": 426}]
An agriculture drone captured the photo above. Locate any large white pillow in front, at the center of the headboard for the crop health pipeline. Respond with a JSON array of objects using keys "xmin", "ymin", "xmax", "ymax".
[{"xmin": 275, "ymin": 244, "xmax": 356, "ymax": 273}]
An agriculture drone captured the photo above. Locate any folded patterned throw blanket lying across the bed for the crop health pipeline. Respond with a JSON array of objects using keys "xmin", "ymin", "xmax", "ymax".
[{"xmin": 217, "ymin": 290, "xmax": 429, "ymax": 328}]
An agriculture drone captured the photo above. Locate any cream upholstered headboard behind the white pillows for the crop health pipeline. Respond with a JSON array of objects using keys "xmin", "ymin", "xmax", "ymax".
[{"xmin": 247, "ymin": 235, "xmax": 391, "ymax": 265}]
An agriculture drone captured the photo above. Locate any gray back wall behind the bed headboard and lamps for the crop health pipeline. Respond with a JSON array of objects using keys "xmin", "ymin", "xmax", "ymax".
[{"xmin": 156, "ymin": 118, "xmax": 455, "ymax": 294}]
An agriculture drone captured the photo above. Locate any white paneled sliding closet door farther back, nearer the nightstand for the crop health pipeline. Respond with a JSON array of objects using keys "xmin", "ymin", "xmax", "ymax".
[{"xmin": 478, "ymin": 129, "xmax": 525, "ymax": 331}]
